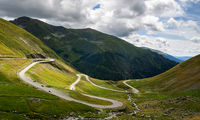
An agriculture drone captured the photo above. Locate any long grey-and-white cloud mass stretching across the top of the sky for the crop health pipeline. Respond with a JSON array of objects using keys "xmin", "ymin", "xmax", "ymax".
[{"xmin": 0, "ymin": 0, "xmax": 183, "ymax": 36}]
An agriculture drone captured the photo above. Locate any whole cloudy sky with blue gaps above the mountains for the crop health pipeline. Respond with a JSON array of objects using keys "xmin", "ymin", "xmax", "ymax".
[{"xmin": 0, "ymin": 0, "xmax": 200, "ymax": 56}]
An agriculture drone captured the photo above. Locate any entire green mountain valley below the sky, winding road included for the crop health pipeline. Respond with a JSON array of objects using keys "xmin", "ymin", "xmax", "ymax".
[{"xmin": 0, "ymin": 17, "xmax": 200, "ymax": 120}]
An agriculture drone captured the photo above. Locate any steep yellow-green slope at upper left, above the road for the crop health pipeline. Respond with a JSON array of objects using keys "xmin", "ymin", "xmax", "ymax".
[{"xmin": 0, "ymin": 18, "xmax": 59, "ymax": 58}]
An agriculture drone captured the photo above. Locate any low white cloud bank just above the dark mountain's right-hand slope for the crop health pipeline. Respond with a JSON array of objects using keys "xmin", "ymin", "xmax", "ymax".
[{"xmin": 123, "ymin": 34, "xmax": 200, "ymax": 56}]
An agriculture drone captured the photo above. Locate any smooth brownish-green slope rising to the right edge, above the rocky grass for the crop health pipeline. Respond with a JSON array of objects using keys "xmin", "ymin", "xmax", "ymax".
[{"xmin": 128, "ymin": 55, "xmax": 200, "ymax": 93}]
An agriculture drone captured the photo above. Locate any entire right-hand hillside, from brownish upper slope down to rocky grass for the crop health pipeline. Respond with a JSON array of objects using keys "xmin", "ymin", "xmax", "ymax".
[{"xmin": 123, "ymin": 55, "xmax": 200, "ymax": 119}]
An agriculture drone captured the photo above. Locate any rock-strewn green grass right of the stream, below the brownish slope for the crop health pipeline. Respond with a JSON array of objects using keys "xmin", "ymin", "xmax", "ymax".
[{"xmin": 127, "ymin": 79, "xmax": 200, "ymax": 119}]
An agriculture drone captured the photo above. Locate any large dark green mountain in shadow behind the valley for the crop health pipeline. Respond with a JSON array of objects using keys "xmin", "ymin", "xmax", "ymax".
[{"xmin": 12, "ymin": 17, "xmax": 177, "ymax": 80}]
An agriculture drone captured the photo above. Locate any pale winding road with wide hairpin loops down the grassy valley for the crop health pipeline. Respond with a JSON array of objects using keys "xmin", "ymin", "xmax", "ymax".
[{"xmin": 18, "ymin": 59, "xmax": 123, "ymax": 109}]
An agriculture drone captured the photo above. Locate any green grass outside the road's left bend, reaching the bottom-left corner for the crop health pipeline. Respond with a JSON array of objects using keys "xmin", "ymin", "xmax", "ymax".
[{"xmin": 0, "ymin": 59, "xmax": 95, "ymax": 120}]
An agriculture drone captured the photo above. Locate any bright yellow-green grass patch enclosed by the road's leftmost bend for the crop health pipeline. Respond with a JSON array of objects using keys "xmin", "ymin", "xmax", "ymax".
[{"xmin": 27, "ymin": 64, "xmax": 77, "ymax": 89}]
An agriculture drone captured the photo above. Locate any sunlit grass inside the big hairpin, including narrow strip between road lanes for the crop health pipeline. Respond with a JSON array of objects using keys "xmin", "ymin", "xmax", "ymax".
[{"xmin": 27, "ymin": 64, "xmax": 111, "ymax": 105}]
